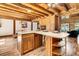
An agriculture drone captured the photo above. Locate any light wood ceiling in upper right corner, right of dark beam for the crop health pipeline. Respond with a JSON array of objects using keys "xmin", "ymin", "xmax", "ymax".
[{"xmin": 61, "ymin": 3, "xmax": 79, "ymax": 15}]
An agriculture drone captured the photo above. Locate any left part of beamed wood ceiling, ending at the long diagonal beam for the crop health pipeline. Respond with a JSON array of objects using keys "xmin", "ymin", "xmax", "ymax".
[{"xmin": 0, "ymin": 3, "xmax": 54, "ymax": 20}]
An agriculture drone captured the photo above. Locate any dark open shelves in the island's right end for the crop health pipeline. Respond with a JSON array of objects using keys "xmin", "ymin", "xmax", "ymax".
[{"xmin": 52, "ymin": 38, "xmax": 64, "ymax": 56}]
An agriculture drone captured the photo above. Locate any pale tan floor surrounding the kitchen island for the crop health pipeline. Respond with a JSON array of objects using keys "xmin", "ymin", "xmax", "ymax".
[{"xmin": 0, "ymin": 37, "xmax": 79, "ymax": 56}]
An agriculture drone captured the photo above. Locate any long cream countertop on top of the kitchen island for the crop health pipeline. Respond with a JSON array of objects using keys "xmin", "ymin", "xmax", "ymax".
[{"xmin": 18, "ymin": 31, "xmax": 69, "ymax": 38}]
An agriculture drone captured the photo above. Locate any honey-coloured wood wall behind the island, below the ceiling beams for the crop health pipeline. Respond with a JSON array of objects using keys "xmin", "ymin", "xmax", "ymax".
[{"xmin": 34, "ymin": 15, "xmax": 55, "ymax": 31}]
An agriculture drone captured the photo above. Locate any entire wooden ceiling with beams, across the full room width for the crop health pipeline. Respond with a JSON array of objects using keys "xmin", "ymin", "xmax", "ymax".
[{"xmin": 0, "ymin": 3, "xmax": 79, "ymax": 20}]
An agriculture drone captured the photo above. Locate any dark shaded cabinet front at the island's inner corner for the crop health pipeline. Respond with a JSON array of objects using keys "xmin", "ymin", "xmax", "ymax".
[{"xmin": 34, "ymin": 34, "xmax": 42, "ymax": 48}]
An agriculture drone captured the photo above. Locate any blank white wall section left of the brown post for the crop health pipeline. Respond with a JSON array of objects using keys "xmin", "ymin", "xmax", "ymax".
[{"xmin": 0, "ymin": 19, "xmax": 13, "ymax": 36}]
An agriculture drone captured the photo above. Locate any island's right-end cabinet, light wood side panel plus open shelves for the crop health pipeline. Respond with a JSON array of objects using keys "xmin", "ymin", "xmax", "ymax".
[{"xmin": 46, "ymin": 37, "xmax": 66, "ymax": 56}]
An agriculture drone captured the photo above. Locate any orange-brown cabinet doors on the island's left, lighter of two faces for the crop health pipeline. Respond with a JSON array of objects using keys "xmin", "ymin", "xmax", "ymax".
[{"xmin": 22, "ymin": 34, "xmax": 34, "ymax": 54}]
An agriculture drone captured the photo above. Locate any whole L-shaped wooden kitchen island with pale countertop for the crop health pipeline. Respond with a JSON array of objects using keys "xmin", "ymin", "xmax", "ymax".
[{"xmin": 18, "ymin": 31, "xmax": 69, "ymax": 56}]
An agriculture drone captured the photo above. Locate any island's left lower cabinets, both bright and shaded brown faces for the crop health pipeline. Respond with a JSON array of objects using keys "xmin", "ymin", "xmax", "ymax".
[{"xmin": 20, "ymin": 33, "xmax": 42, "ymax": 55}]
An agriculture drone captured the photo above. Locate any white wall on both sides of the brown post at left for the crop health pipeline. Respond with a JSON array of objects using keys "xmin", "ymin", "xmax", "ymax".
[{"xmin": 0, "ymin": 19, "xmax": 31, "ymax": 36}]
